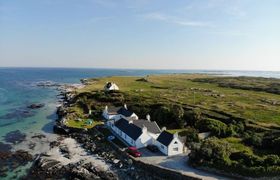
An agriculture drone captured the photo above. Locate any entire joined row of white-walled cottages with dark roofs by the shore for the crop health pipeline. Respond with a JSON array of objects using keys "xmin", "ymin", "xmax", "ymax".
[{"xmin": 103, "ymin": 105, "xmax": 185, "ymax": 156}]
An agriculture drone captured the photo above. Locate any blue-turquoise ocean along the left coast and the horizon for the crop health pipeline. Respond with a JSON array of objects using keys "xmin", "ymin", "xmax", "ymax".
[{"xmin": 0, "ymin": 68, "xmax": 280, "ymax": 179}]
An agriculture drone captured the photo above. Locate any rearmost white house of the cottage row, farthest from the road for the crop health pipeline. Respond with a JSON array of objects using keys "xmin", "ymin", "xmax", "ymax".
[{"xmin": 102, "ymin": 104, "xmax": 138, "ymax": 124}]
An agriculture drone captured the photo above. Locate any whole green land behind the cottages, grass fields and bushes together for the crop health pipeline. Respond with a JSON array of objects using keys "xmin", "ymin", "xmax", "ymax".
[{"xmin": 67, "ymin": 74, "xmax": 280, "ymax": 177}]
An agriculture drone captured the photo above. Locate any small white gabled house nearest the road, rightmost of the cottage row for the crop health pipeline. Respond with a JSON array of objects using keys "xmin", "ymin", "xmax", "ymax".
[{"xmin": 155, "ymin": 131, "xmax": 184, "ymax": 156}]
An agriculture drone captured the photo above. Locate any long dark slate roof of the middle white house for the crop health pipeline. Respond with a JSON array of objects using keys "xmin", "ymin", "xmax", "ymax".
[{"xmin": 115, "ymin": 119, "xmax": 142, "ymax": 140}]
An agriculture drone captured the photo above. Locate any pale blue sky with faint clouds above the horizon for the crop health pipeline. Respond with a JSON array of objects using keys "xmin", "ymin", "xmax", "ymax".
[{"xmin": 0, "ymin": 0, "xmax": 280, "ymax": 71}]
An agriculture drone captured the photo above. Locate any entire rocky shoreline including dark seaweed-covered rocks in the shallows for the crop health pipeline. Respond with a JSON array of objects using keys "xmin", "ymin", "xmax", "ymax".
[{"xmin": 0, "ymin": 79, "xmax": 201, "ymax": 180}]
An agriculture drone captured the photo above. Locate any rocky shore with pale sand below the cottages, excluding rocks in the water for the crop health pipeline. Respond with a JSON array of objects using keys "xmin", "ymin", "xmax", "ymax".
[{"xmin": 22, "ymin": 80, "xmax": 164, "ymax": 180}]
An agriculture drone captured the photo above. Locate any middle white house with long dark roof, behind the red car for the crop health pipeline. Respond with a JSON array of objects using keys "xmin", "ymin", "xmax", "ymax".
[{"xmin": 111, "ymin": 118, "xmax": 161, "ymax": 148}]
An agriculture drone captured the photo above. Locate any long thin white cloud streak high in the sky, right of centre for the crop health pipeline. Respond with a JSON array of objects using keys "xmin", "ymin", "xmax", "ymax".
[{"xmin": 142, "ymin": 12, "xmax": 212, "ymax": 27}]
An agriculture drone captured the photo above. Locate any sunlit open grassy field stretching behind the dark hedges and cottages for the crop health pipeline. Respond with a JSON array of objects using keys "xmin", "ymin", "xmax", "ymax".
[{"xmin": 79, "ymin": 74, "xmax": 280, "ymax": 126}]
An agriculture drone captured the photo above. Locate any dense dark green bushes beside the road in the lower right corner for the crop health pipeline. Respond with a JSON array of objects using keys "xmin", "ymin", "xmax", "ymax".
[{"xmin": 189, "ymin": 138, "xmax": 280, "ymax": 177}]
